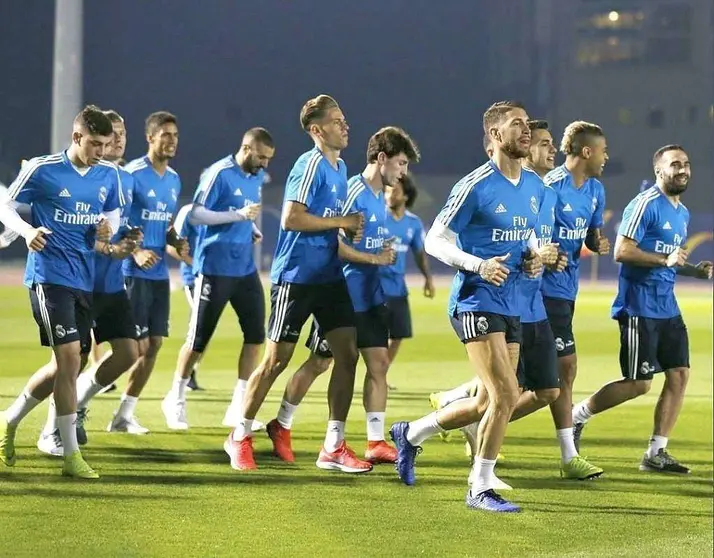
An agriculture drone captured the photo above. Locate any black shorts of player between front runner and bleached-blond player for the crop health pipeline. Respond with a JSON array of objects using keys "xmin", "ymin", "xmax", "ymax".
[{"xmin": 517, "ymin": 320, "xmax": 560, "ymax": 391}]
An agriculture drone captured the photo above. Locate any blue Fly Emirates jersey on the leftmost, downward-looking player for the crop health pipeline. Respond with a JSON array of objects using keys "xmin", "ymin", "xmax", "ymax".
[{"xmin": 8, "ymin": 151, "xmax": 124, "ymax": 292}]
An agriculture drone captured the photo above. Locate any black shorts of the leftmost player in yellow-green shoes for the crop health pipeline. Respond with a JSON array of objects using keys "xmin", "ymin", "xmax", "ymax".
[{"xmin": 30, "ymin": 283, "xmax": 92, "ymax": 353}]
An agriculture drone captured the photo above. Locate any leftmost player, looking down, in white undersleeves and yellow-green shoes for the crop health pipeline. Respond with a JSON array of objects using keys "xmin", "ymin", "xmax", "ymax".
[{"xmin": 0, "ymin": 105, "xmax": 124, "ymax": 479}]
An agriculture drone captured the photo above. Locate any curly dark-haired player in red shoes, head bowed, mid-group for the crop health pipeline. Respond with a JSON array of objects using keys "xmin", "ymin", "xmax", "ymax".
[{"xmin": 267, "ymin": 126, "xmax": 419, "ymax": 466}]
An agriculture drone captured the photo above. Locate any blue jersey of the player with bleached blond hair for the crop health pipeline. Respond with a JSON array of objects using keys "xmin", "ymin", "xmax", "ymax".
[{"xmin": 542, "ymin": 165, "xmax": 605, "ymax": 300}]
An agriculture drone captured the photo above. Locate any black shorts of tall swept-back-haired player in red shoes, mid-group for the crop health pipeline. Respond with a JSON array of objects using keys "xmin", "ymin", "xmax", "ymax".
[{"xmin": 268, "ymin": 280, "xmax": 355, "ymax": 343}]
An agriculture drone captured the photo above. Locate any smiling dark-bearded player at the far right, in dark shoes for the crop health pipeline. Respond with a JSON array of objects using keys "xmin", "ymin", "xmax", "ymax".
[{"xmin": 573, "ymin": 145, "xmax": 712, "ymax": 474}]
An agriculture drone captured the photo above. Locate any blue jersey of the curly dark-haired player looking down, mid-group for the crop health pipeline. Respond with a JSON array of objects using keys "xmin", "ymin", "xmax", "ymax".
[{"xmin": 342, "ymin": 174, "xmax": 387, "ymax": 312}]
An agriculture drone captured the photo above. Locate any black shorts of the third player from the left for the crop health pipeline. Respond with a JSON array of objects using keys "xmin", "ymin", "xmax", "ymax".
[{"xmin": 124, "ymin": 277, "xmax": 171, "ymax": 339}]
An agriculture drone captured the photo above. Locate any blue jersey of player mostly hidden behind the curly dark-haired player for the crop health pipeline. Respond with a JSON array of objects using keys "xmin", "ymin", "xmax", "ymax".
[{"xmin": 379, "ymin": 210, "xmax": 424, "ymax": 297}]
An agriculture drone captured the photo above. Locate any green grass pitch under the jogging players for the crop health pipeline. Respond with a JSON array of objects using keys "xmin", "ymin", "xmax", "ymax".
[{"xmin": 0, "ymin": 286, "xmax": 713, "ymax": 558}]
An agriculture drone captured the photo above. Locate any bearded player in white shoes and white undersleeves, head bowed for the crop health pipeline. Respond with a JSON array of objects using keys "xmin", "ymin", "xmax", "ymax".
[{"xmin": 161, "ymin": 128, "xmax": 275, "ymax": 430}]
